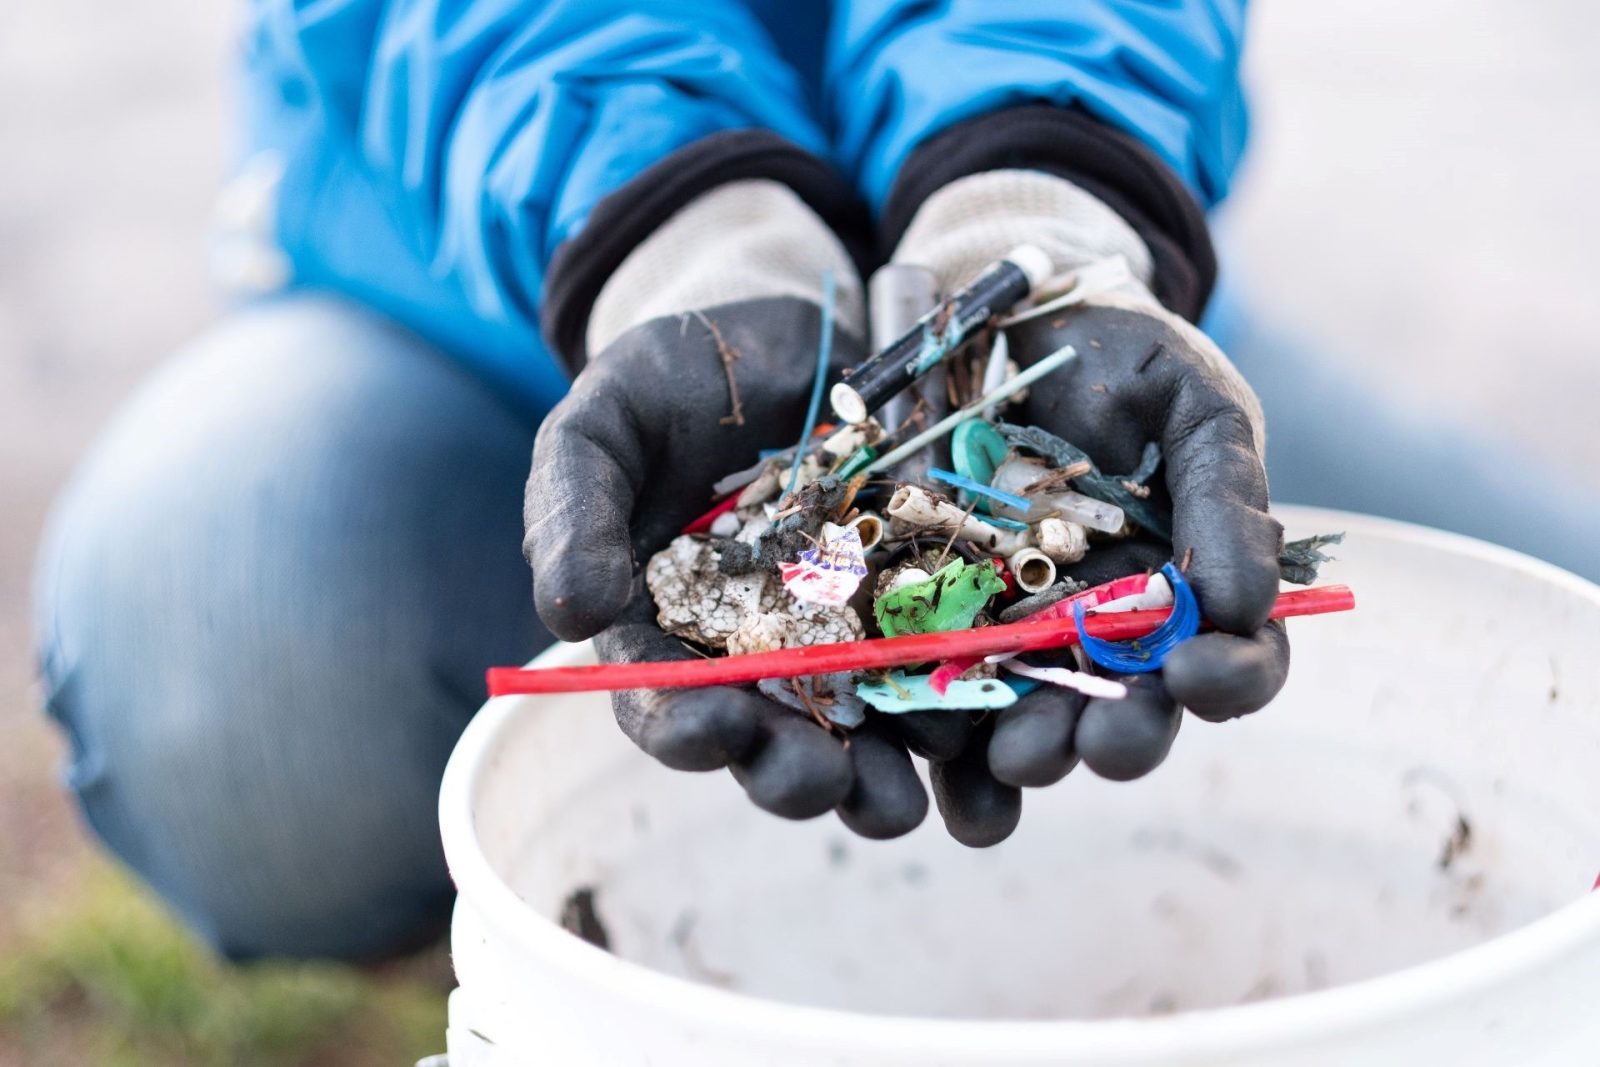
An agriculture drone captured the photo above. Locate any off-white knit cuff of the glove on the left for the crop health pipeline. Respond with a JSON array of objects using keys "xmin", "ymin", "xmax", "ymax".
[{"xmin": 586, "ymin": 179, "xmax": 866, "ymax": 352}]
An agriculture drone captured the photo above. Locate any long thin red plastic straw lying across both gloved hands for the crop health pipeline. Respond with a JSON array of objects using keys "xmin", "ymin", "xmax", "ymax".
[{"xmin": 488, "ymin": 585, "xmax": 1355, "ymax": 696}]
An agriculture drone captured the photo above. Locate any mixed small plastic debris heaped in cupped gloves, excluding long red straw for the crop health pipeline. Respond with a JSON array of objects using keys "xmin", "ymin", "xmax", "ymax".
[{"xmin": 645, "ymin": 246, "xmax": 1339, "ymax": 729}]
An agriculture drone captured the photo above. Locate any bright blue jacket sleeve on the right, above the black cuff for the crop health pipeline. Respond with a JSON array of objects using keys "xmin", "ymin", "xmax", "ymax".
[{"xmin": 826, "ymin": 0, "xmax": 1245, "ymax": 208}]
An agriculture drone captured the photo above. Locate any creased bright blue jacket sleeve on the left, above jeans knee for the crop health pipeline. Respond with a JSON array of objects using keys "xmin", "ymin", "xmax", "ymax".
[{"xmin": 245, "ymin": 0, "xmax": 824, "ymax": 403}]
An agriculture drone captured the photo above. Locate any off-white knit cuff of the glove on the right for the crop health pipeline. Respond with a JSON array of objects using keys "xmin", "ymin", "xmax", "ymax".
[{"xmin": 893, "ymin": 170, "xmax": 1154, "ymax": 300}]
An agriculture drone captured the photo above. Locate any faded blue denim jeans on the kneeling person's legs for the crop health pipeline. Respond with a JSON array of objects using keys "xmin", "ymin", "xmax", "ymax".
[{"xmin": 28, "ymin": 289, "xmax": 1600, "ymax": 958}]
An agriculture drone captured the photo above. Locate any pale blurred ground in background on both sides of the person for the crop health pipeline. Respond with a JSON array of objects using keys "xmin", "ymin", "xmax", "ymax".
[{"xmin": 0, "ymin": 0, "xmax": 1600, "ymax": 941}]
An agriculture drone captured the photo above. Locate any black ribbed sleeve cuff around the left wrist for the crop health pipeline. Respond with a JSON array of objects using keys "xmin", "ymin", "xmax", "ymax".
[{"xmin": 539, "ymin": 130, "xmax": 872, "ymax": 374}]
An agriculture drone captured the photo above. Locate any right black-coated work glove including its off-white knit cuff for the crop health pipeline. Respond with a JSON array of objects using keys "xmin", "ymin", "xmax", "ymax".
[{"xmin": 894, "ymin": 171, "xmax": 1290, "ymax": 838}]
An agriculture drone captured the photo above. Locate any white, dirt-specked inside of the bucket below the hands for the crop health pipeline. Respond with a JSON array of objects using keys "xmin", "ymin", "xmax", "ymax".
[{"xmin": 474, "ymin": 510, "xmax": 1600, "ymax": 1019}]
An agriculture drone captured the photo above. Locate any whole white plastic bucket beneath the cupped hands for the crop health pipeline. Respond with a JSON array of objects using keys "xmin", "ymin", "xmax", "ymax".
[{"xmin": 440, "ymin": 509, "xmax": 1600, "ymax": 1067}]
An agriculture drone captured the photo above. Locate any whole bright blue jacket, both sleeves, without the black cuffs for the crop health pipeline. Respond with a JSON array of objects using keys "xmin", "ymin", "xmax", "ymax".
[{"xmin": 243, "ymin": 0, "xmax": 1245, "ymax": 410}]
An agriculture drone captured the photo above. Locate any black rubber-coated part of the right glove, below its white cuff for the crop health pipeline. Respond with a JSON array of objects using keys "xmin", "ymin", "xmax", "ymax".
[{"xmin": 987, "ymin": 306, "xmax": 1290, "ymax": 785}]
